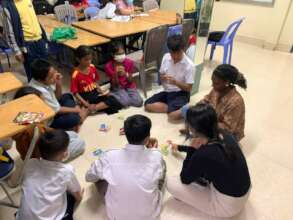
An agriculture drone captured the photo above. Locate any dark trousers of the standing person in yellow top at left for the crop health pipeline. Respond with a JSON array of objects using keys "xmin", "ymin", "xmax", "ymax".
[{"xmin": 23, "ymin": 39, "xmax": 48, "ymax": 82}]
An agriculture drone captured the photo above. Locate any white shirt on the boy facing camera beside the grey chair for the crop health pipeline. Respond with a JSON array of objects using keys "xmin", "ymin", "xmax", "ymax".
[{"xmin": 160, "ymin": 53, "xmax": 195, "ymax": 92}]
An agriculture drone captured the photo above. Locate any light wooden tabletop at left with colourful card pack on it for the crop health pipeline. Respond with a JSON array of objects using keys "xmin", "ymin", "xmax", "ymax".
[{"xmin": 0, "ymin": 95, "xmax": 55, "ymax": 139}]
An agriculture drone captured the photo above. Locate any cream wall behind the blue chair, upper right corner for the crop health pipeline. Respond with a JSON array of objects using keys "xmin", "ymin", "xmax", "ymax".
[{"xmin": 211, "ymin": 0, "xmax": 293, "ymax": 49}]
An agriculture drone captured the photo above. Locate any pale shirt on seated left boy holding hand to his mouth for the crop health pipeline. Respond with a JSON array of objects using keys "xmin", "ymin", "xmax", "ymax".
[{"xmin": 29, "ymin": 79, "xmax": 61, "ymax": 113}]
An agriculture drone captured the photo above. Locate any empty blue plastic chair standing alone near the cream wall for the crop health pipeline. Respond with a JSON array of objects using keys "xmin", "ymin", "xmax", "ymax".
[{"xmin": 208, "ymin": 18, "xmax": 244, "ymax": 64}]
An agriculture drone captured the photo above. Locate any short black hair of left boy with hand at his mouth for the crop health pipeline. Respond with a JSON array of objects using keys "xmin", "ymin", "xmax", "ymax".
[{"xmin": 31, "ymin": 59, "xmax": 52, "ymax": 81}]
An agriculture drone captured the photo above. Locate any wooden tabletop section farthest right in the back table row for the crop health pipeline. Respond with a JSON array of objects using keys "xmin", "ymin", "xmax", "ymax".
[{"xmin": 135, "ymin": 10, "xmax": 177, "ymax": 25}]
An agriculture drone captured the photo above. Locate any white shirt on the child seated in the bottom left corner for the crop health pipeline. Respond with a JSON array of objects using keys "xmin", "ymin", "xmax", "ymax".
[{"xmin": 16, "ymin": 159, "xmax": 81, "ymax": 220}]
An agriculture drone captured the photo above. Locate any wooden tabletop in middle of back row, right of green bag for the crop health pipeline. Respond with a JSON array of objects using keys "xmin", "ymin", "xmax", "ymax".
[{"xmin": 73, "ymin": 19, "xmax": 160, "ymax": 39}]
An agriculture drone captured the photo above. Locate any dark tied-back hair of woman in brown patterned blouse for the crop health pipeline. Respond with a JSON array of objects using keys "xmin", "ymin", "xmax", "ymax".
[{"xmin": 213, "ymin": 64, "xmax": 247, "ymax": 89}]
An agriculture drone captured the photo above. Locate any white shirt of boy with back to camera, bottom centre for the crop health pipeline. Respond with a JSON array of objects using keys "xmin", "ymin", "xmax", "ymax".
[{"xmin": 86, "ymin": 144, "xmax": 166, "ymax": 220}]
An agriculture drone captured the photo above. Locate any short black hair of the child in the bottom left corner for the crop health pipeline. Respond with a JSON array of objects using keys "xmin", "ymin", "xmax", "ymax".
[{"xmin": 37, "ymin": 130, "xmax": 69, "ymax": 160}]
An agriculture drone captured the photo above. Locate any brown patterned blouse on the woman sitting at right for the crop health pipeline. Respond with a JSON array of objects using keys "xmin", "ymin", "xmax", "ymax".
[{"xmin": 203, "ymin": 88, "xmax": 245, "ymax": 141}]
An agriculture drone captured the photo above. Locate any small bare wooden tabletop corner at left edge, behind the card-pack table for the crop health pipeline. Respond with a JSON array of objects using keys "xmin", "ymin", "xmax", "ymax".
[{"xmin": 0, "ymin": 72, "xmax": 23, "ymax": 94}]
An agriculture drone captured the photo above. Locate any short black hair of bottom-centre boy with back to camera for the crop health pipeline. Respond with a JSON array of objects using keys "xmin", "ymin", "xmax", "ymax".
[{"xmin": 124, "ymin": 115, "xmax": 152, "ymax": 144}]
